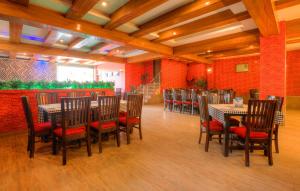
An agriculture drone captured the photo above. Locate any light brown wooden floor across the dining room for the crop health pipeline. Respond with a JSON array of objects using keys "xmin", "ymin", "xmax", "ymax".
[{"xmin": 0, "ymin": 106, "xmax": 300, "ymax": 191}]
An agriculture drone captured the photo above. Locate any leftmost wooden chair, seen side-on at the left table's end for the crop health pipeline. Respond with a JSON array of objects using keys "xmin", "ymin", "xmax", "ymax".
[{"xmin": 21, "ymin": 96, "xmax": 51, "ymax": 158}]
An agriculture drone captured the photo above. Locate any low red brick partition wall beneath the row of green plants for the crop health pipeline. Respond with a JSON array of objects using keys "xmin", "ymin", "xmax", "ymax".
[{"xmin": 0, "ymin": 89, "xmax": 114, "ymax": 133}]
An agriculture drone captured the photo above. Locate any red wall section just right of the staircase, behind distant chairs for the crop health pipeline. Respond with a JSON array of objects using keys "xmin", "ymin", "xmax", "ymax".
[{"xmin": 161, "ymin": 59, "xmax": 188, "ymax": 89}]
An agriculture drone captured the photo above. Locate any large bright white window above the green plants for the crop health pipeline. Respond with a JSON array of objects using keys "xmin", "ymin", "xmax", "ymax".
[{"xmin": 57, "ymin": 65, "xmax": 94, "ymax": 82}]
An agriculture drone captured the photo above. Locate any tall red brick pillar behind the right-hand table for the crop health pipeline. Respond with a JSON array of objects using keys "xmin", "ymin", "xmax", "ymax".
[{"xmin": 260, "ymin": 21, "xmax": 286, "ymax": 99}]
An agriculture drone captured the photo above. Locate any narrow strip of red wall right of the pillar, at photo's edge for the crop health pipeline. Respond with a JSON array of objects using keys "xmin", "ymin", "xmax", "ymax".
[{"xmin": 287, "ymin": 50, "xmax": 300, "ymax": 96}]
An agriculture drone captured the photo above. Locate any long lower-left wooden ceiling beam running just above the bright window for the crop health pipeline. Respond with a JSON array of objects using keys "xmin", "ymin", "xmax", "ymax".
[{"xmin": 0, "ymin": 40, "xmax": 126, "ymax": 63}]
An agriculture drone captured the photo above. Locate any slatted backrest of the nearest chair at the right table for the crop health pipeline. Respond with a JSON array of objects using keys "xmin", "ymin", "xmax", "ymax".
[{"xmin": 246, "ymin": 100, "xmax": 276, "ymax": 136}]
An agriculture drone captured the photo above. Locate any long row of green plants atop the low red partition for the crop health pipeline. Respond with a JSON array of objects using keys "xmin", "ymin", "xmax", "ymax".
[{"xmin": 0, "ymin": 80, "xmax": 115, "ymax": 90}]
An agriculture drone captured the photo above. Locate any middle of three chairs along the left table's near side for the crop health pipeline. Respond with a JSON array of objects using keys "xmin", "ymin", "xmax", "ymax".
[{"xmin": 91, "ymin": 96, "xmax": 120, "ymax": 153}]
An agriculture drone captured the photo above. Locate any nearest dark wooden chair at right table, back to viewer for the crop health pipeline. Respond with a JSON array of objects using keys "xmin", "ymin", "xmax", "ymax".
[{"xmin": 231, "ymin": 100, "xmax": 276, "ymax": 166}]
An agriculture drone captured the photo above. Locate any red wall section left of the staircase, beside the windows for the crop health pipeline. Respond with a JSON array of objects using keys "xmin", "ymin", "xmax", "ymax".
[{"xmin": 125, "ymin": 61, "xmax": 153, "ymax": 91}]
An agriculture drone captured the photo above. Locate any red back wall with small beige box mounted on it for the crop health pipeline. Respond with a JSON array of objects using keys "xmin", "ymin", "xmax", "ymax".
[{"xmin": 207, "ymin": 56, "xmax": 260, "ymax": 95}]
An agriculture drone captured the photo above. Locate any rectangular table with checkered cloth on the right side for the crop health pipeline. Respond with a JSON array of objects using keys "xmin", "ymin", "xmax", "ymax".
[{"xmin": 208, "ymin": 104, "xmax": 284, "ymax": 157}]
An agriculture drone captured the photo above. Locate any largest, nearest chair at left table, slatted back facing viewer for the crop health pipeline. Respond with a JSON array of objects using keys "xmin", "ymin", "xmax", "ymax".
[{"xmin": 53, "ymin": 97, "xmax": 92, "ymax": 165}]
